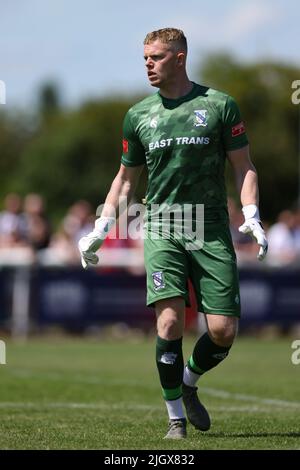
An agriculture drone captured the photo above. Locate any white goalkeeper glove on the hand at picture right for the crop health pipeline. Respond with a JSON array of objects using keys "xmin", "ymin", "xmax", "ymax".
[{"xmin": 239, "ymin": 204, "xmax": 268, "ymax": 261}]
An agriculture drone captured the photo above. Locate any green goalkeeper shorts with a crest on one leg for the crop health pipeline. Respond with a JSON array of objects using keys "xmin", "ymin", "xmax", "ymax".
[{"xmin": 144, "ymin": 225, "xmax": 240, "ymax": 317}]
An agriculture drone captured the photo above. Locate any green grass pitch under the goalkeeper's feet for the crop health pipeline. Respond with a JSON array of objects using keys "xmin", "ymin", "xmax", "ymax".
[{"xmin": 0, "ymin": 337, "xmax": 300, "ymax": 450}]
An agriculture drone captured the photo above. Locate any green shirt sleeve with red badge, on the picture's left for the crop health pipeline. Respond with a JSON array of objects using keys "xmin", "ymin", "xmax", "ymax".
[{"xmin": 121, "ymin": 110, "xmax": 146, "ymax": 166}]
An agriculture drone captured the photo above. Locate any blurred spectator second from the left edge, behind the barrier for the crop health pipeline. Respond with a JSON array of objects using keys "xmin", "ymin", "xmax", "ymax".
[{"xmin": 23, "ymin": 193, "xmax": 51, "ymax": 251}]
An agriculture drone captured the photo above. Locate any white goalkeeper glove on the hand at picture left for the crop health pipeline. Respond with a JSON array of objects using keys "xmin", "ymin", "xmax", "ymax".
[{"xmin": 78, "ymin": 217, "xmax": 116, "ymax": 269}]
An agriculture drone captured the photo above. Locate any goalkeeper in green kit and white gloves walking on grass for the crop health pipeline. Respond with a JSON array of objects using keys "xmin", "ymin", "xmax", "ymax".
[{"xmin": 79, "ymin": 28, "xmax": 267, "ymax": 439}]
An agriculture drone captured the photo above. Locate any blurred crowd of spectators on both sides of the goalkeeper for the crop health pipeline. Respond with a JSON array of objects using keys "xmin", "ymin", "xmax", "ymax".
[{"xmin": 0, "ymin": 193, "xmax": 300, "ymax": 273}]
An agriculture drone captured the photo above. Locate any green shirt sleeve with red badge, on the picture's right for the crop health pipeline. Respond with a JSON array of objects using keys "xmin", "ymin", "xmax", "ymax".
[{"xmin": 223, "ymin": 96, "xmax": 248, "ymax": 150}]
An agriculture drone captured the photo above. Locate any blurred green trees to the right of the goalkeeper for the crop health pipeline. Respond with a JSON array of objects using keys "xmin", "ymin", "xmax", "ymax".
[{"xmin": 199, "ymin": 54, "xmax": 300, "ymax": 220}]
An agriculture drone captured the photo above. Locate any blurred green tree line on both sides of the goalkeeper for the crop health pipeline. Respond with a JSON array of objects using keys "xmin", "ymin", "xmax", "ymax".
[{"xmin": 0, "ymin": 54, "xmax": 300, "ymax": 221}]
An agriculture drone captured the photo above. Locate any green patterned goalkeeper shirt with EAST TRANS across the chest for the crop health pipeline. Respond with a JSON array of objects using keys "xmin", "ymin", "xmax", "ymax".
[{"xmin": 121, "ymin": 83, "xmax": 248, "ymax": 223}]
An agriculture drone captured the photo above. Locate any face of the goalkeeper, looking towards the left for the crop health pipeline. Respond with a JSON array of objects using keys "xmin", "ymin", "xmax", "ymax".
[{"xmin": 144, "ymin": 40, "xmax": 182, "ymax": 88}]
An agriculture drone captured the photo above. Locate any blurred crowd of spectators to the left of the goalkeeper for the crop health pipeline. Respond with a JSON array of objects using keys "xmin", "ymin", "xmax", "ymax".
[{"xmin": 0, "ymin": 193, "xmax": 143, "ymax": 274}]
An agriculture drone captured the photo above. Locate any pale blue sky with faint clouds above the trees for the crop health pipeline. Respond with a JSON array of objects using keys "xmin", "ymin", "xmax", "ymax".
[{"xmin": 0, "ymin": 0, "xmax": 300, "ymax": 107}]
